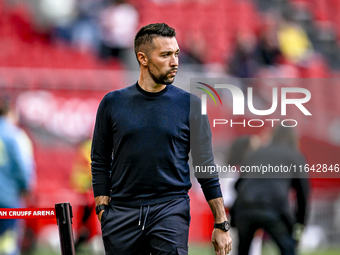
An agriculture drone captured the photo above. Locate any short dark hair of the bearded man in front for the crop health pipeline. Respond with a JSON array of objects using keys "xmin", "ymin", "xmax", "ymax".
[{"xmin": 134, "ymin": 23, "xmax": 176, "ymax": 60}]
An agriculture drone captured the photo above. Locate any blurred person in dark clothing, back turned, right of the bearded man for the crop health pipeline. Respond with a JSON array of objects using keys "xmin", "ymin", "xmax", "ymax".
[{"xmin": 232, "ymin": 126, "xmax": 309, "ymax": 255}]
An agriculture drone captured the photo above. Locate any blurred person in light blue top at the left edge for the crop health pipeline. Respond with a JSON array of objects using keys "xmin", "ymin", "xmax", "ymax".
[{"xmin": 0, "ymin": 96, "xmax": 34, "ymax": 255}]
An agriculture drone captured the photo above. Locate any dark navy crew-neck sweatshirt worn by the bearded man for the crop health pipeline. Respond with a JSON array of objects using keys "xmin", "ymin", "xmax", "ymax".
[{"xmin": 91, "ymin": 83, "xmax": 222, "ymax": 206}]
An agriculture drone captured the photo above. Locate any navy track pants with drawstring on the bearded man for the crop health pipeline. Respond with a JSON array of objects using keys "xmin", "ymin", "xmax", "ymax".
[{"xmin": 101, "ymin": 197, "xmax": 190, "ymax": 255}]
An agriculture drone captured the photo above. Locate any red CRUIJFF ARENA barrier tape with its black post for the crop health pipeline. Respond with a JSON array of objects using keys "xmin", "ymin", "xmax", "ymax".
[{"xmin": 0, "ymin": 203, "xmax": 76, "ymax": 255}]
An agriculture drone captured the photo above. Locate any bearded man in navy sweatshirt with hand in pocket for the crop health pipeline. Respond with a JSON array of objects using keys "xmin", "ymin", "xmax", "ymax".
[{"xmin": 91, "ymin": 23, "xmax": 231, "ymax": 255}]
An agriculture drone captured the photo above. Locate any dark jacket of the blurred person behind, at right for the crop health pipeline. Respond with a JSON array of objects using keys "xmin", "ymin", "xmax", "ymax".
[{"xmin": 234, "ymin": 144, "xmax": 309, "ymax": 229}]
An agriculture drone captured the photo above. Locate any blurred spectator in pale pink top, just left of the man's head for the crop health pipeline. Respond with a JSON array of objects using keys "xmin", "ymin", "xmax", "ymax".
[{"xmin": 100, "ymin": 0, "xmax": 139, "ymax": 66}]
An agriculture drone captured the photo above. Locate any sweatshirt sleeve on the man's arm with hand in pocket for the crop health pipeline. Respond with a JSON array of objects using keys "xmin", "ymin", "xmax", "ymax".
[{"xmin": 91, "ymin": 95, "xmax": 113, "ymax": 197}]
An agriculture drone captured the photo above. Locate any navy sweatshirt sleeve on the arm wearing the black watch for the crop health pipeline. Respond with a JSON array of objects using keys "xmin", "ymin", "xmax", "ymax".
[{"xmin": 190, "ymin": 95, "xmax": 222, "ymax": 201}]
